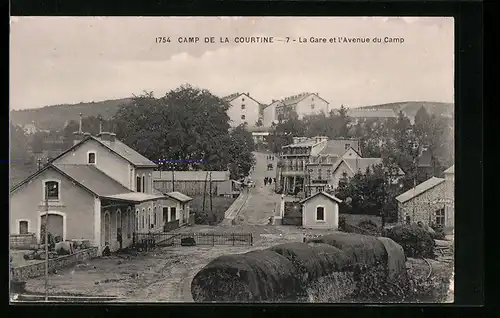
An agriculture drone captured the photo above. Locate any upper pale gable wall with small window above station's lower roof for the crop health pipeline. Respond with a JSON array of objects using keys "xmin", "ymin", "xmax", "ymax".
[{"xmin": 54, "ymin": 140, "xmax": 130, "ymax": 188}]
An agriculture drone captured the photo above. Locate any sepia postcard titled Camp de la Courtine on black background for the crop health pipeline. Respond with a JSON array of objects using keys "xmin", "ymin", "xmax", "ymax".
[{"xmin": 9, "ymin": 16, "xmax": 455, "ymax": 304}]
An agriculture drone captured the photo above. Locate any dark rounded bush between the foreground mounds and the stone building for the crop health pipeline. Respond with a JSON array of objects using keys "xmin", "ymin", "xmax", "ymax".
[{"xmin": 384, "ymin": 225, "xmax": 435, "ymax": 258}]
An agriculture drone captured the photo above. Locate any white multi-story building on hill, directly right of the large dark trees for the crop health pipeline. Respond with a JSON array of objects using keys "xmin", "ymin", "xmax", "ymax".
[{"xmin": 222, "ymin": 93, "xmax": 262, "ymax": 127}]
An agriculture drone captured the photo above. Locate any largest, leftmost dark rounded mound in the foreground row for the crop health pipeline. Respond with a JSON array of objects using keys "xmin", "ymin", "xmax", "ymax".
[{"xmin": 191, "ymin": 250, "xmax": 301, "ymax": 302}]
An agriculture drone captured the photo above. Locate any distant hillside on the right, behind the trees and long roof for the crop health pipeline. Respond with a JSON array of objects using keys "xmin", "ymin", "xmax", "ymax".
[{"xmin": 358, "ymin": 102, "xmax": 455, "ymax": 117}]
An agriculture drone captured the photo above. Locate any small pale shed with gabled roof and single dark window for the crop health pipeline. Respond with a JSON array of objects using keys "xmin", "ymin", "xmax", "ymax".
[{"xmin": 300, "ymin": 191, "xmax": 342, "ymax": 230}]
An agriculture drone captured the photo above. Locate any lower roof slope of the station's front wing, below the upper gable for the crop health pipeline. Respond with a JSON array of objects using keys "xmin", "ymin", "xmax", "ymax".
[{"xmin": 54, "ymin": 164, "xmax": 132, "ymax": 197}]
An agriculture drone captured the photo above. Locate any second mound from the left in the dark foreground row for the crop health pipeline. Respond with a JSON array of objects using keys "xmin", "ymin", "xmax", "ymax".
[{"xmin": 269, "ymin": 243, "xmax": 351, "ymax": 284}]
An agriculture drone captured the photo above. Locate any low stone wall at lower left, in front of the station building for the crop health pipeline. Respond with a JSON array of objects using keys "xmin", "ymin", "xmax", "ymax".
[{"xmin": 11, "ymin": 247, "xmax": 97, "ymax": 281}]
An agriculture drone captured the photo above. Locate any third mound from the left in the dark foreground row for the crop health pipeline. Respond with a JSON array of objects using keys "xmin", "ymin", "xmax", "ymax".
[{"xmin": 307, "ymin": 232, "xmax": 387, "ymax": 266}]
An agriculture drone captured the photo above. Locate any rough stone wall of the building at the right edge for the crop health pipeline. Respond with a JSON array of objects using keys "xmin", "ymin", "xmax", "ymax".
[{"xmin": 398, "ymin": 182, "xmax": 445, "ymax": 225}]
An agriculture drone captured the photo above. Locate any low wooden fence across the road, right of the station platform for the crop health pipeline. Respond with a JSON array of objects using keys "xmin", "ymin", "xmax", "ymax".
[{"xmin": 134, "ymin": 233, "xmax": 253, "ymax": 249}]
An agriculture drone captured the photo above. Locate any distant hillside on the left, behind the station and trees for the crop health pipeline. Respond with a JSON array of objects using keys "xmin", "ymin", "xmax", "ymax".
[{"xmin": 10, "ymin": 98, "xmax": 132, "ymax": 130}]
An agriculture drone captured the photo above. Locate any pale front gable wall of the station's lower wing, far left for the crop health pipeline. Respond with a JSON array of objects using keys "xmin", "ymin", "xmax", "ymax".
[{"xmin": 10, "ymin": 168, "xmax": 94, "ymax": 241}]
